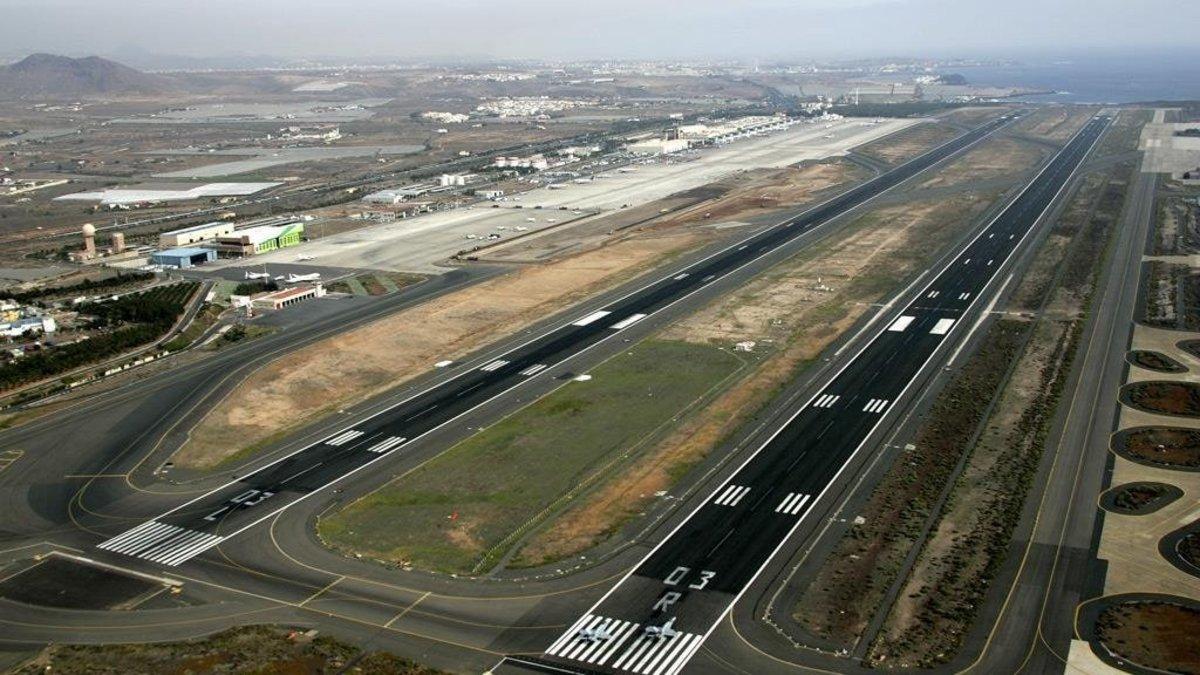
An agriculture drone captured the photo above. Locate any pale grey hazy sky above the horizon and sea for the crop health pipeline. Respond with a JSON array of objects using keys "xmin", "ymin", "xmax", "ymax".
[{"xmin": 0, "ymin": 0, "xmax": 1200, "ymax": 59}]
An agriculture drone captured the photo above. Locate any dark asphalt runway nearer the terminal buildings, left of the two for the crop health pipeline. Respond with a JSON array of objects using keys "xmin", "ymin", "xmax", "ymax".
[{"xmin": 91, "ymin": 117, "xmax": 1012, "ymax": 566}]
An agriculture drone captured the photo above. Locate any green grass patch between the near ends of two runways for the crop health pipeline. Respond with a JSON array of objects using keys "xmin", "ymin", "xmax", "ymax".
[{"xmin": 319, "ymin": 341, "xmax": 742, "ymax": 574}]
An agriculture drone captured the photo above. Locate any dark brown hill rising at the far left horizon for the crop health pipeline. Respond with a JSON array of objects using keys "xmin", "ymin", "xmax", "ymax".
[{"xmin": 0, "ymin": 54, "xmax": 173, "ymax": 98}]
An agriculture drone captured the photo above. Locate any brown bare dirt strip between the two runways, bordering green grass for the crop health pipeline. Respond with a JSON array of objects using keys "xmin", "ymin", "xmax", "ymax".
[{"xmin": 520, "ymin": 196, "xmax": 989, "ymax": 561}]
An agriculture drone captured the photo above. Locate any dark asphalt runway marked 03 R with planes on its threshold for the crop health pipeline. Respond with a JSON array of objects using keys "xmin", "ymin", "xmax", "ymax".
[{"xmin": 530, "ymin": 117, "xmax": 1109, "ymax": 675}]
